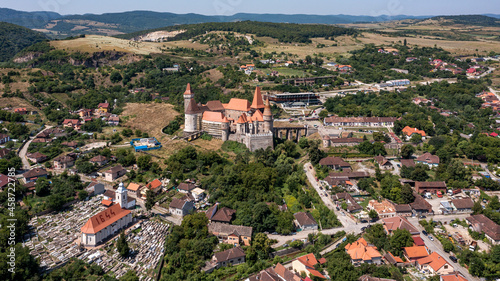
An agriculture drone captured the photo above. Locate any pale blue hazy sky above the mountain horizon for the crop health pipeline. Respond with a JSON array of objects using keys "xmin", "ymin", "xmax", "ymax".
[{"xmin": 0, "ymin": 0, "xmax": 500, "ymax": 16}]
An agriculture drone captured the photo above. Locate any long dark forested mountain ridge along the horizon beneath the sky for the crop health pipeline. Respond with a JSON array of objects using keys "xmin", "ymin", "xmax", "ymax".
[{"xmin": 0, "ymin": 8, "xmax": 426, "ymax": 38}]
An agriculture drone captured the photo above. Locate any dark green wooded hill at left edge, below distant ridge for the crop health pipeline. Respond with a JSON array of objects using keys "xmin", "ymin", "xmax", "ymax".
[{"xmin": 0, "ymin": 22, "xmax": 47, "ymax": 62}]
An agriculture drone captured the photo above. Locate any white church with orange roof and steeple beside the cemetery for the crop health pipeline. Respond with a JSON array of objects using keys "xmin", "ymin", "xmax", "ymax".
[{"xmin": 81, "ymin": 183, "xmax": 135, "ymax": 247}]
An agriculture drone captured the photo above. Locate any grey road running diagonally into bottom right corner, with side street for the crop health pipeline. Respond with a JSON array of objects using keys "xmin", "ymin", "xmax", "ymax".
[{"xmin": 408, "ymin": 215, "xmax": 479, "ymax": 281}]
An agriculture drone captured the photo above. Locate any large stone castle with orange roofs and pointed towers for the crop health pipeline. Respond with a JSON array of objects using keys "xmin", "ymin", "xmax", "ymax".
[{"xmin": 184, "ymin": 84, "xmax": 273, "ymax": 152}]
